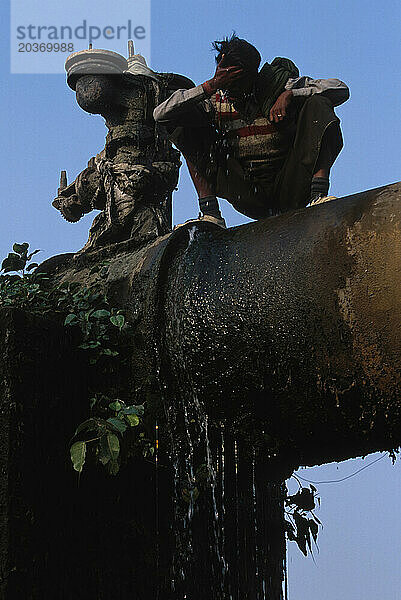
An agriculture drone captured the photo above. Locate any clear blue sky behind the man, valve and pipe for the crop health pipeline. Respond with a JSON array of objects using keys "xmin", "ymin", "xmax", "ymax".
[{"xmin": 0, "ymin": 0, "xmax": 401, "ymax": 600}]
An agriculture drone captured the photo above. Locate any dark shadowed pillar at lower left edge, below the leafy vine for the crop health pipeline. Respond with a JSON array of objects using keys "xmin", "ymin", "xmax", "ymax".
[{"xmin": 0, "ymin": 308, "xmax": 86, "ymax": 600}]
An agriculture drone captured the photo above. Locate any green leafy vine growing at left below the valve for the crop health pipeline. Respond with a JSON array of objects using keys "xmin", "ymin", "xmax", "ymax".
[{"xmin": 0, "ymin": 242, "xmax": 154, "ymax": 475}]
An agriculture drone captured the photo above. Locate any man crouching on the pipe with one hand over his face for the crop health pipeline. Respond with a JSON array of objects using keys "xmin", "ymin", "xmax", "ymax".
[{"xmin": 153, "ymin": 34, "xmax": 349, "ymax": 227}]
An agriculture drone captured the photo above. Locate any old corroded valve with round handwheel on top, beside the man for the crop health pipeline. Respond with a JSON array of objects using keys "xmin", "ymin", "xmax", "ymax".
[{"xmin": 53, "ymin": 40, "xmax": 194, "ymax": 252}]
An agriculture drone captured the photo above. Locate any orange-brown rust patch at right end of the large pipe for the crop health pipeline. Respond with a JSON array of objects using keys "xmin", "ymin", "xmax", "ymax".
[{"xmin": 337, "ymin": 202, "xmax": 401, "ymax": 395}]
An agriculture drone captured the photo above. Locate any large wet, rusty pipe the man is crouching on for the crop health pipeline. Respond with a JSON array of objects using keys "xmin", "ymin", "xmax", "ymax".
[{"xmin": 39, "ymin": 183, "xmax": 401, "ymax": 472}]
